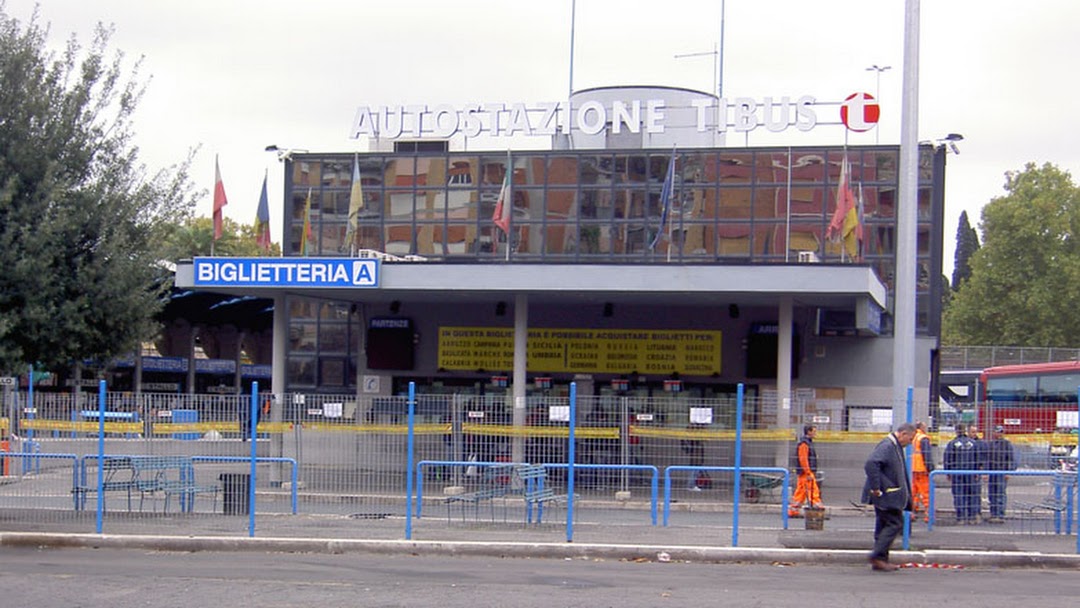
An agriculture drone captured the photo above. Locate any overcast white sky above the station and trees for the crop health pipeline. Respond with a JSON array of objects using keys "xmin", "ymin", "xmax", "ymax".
[{"xmin": 8, "ymin": 0, "xmax": 1080, "ymax": 275}]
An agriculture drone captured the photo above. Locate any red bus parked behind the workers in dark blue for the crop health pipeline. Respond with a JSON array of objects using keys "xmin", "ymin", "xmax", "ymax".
[{"xmin": 977, "ymin": 361, "xmax": 1080, "ymax": 436}]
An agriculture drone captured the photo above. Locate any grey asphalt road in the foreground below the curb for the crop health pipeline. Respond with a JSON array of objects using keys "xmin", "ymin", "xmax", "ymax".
[{"xmin": 0, "ymin": 546, "xmax": 1080, "ymax": 608}]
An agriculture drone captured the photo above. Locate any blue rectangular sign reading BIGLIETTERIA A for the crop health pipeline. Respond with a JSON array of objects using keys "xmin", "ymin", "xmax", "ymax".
[{"xmin": 194, "ymin": 257, "xmax": 379, "ymax": 288}]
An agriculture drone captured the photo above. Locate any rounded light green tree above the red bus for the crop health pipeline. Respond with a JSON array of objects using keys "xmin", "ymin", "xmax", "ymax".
[{"xmin": 943, "ymin": 163, "xmax": 1080, "ymax": 347}]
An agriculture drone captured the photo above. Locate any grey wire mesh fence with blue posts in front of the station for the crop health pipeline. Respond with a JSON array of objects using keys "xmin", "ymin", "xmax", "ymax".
[{"xmin": 0, "ymin": 384, "xmax": 1075, "ymax": 542}]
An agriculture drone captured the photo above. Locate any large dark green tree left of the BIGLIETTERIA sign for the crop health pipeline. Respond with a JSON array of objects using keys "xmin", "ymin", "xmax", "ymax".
[{"xmin": 0, "ymin": 9, "xmax": 194, "ymax": 374}]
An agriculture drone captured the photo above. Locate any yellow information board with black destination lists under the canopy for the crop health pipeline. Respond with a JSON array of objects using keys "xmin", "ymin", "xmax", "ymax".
[{"xmin": 438, "ymin": 327, "xmax": 720, "ymax": 376}]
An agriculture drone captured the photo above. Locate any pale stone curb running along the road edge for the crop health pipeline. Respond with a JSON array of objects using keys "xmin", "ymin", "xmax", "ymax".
[{"xmin": 0, "ymin": 532, "xmax": 1080, "ymax": 570}]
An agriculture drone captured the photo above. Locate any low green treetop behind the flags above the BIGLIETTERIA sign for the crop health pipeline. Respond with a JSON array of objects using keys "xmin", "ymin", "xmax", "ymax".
[{"xmin": 159, "ymin": 217, "xmax": 281, "ymax": 260}]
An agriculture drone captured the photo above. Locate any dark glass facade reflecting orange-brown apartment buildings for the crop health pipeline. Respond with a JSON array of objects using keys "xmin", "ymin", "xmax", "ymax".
[{"xmin": 284, "ymin": 147, "xmax": 944, "ymax": 388}]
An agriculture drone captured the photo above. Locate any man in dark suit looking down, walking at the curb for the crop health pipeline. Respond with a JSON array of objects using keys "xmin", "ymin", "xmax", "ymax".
[{"xmin": 863, "ymin": 422, "xmax": 915, "ymax": 572}]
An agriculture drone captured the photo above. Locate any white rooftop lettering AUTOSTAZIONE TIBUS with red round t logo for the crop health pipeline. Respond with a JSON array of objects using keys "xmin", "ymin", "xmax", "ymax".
[{"xmin": 350, "ymin": 93, "xmax": 879, "ymax": 139}]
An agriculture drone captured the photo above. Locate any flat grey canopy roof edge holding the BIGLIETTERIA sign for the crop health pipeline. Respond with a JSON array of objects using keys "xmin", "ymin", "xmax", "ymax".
[{"xmin": 176, "ymin": 260, "xmax": 886, "ymax": 309}]
